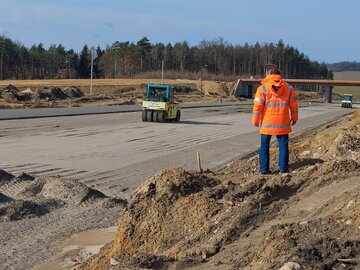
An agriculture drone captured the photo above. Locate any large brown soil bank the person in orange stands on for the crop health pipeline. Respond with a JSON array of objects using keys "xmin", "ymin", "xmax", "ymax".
[{"xmin": 79, "ymin": 112, "xmax": 360, "ymax": 270}]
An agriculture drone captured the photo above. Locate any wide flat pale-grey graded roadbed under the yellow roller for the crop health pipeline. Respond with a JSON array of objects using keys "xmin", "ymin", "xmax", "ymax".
[{"xmin": 0, "ymin": 104, "xmax": 352, "ymax": 198}]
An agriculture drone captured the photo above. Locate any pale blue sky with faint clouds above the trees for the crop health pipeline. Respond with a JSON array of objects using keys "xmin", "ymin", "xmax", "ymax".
[{"xmin": 0, "ymin": 0, "xmax": 360, "ymax": 63}]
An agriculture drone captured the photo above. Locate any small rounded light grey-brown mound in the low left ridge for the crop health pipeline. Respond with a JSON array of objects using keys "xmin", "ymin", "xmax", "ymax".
[{"xmin": 19, "ymin": 177, "xmax": 106, "ymax": 204}]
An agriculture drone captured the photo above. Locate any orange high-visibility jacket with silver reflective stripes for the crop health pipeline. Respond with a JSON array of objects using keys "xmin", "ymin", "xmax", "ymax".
[{"xmin": 252, "ymin": 74, "xmax": 298, "ymax": 135}]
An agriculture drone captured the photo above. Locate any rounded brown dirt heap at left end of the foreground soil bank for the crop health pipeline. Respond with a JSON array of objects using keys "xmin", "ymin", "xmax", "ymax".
[{"xmin": 114, "ymin": 168, "xmax": 218, "ymax": 256}]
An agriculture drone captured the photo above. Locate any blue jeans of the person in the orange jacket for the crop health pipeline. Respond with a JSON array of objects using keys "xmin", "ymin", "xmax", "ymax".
[{"xmin": 259, "ymin": 134, "xmax": 289, "ymax": 173}]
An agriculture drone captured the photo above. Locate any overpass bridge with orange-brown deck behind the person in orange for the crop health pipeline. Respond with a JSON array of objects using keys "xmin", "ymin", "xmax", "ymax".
[{"xmin": 233, "ymin": 79, "xmax": 360, "ymax": 103}]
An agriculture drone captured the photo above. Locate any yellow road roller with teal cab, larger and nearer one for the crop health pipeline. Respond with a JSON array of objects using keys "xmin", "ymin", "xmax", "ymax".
[{"xmin": 142, "ymin": 84, "xmax": 181, "ymax": 122}]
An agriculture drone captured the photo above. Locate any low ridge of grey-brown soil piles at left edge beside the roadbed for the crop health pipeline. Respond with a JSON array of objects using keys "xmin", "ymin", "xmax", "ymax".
[{"xmin": 0, "ymin": 170, "xmax": 126, "ymax": 222}]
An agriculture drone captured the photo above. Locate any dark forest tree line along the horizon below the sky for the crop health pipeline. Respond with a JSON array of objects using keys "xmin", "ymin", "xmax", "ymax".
[{"xmin": 0, "ymin": 36, "xmax": 333, "ymax": 80}]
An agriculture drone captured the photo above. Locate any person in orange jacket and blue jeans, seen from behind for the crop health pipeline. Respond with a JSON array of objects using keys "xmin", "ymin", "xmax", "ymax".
[{"xmin": 252, "ymin": 65, "xmax": 298, "ymax": 174}]
